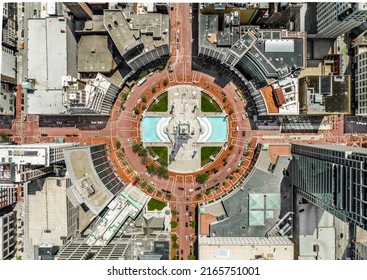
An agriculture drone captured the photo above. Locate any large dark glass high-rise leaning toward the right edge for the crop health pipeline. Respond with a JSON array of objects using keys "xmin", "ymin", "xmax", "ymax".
[{"xmin": 289, "ymin": 144, "xmax": 367, "ymax": 230}]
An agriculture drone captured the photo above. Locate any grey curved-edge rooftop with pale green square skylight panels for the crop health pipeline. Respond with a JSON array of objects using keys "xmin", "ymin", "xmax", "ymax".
[{"xmin": 205, "ymin": 151, "xmax": 289, "ymax": 237}]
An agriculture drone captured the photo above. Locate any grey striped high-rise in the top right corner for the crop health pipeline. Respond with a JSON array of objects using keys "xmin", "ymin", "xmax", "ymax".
[{"xmin": 316, "ymin": 2, "xmax": 367, "ymax": 38}]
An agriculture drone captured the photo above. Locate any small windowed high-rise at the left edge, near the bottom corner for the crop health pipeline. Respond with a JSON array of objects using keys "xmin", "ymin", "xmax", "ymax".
[{"xmin": 0, "ymin": 208, "xmax": 17, "ymax": 260}]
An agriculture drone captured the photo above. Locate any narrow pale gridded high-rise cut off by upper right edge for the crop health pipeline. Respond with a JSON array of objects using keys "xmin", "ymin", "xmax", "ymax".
[{"xmin": 354, "ymin": 46, "xmax": 367, "ymax": 116}]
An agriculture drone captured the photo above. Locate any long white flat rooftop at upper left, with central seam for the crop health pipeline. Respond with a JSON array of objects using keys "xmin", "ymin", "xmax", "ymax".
[{"xmin": 26, "ymin": 17, "xmax": 67, "ymax": 115}]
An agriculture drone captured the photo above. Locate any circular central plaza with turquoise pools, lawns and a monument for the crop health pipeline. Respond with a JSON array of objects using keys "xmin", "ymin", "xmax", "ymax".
[{"xmin": 140, "ymin": 85, "xmax": 228, "ymax": 173}]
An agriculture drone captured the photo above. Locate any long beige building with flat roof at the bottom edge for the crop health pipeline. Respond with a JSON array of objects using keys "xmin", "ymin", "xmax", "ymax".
[{"xmin": 199, "ymin": 236, "xmax": 294, "ymax": 260}]
